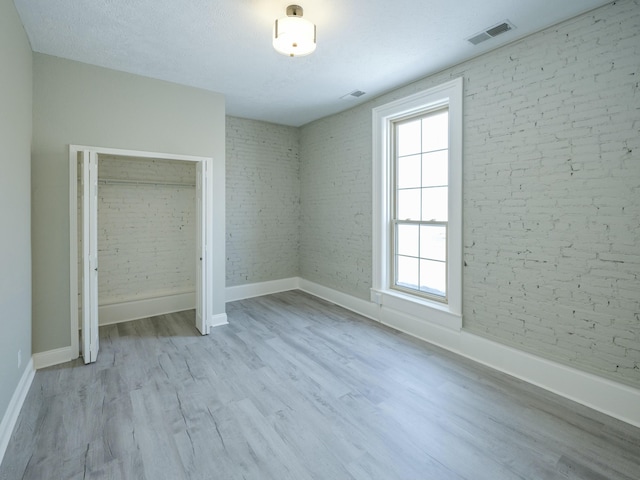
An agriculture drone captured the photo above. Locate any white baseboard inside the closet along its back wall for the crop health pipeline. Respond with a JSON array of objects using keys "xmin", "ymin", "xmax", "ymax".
[{"xmin": 98, "ymin": 292, "xmax": 196, "ymax": 326}]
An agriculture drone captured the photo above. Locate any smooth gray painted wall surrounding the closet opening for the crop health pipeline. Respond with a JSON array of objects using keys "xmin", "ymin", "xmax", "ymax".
[{"xmin": 32, "ymin": 54, "xmax": 225, "ymax": 352}]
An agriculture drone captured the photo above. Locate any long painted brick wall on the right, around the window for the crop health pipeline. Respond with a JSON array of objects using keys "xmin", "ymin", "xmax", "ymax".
[{"xmin": 300, "ymin": 0, "xmax": 640, "ymax": 387}]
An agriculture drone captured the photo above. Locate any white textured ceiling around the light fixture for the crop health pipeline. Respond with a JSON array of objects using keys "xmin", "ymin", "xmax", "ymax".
[{"xmin": 15, "ymin": 0, "xmax": 610, "ymax": 126}]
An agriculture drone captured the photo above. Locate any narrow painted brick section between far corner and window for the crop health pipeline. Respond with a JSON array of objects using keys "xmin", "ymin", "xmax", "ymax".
[{"xmin": 300, "ymin": 108, "xmax": 372, "ymax": 299}]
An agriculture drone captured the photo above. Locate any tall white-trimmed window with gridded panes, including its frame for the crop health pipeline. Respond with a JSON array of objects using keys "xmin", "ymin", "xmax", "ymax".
[{"xmin": 372, "ymin": 79, "xmax": 462, "ymax": 328}]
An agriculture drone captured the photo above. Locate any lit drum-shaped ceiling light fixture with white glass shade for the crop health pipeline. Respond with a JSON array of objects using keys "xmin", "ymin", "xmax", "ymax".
[{"xmin": 273, "ymin": 5, "xmax": 316, "ymax": 57}]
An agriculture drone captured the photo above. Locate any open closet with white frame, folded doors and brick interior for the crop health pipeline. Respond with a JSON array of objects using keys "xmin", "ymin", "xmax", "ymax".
[{"xmin": 69, "ymin": 145, "xmax": 226, "ymax": 363}]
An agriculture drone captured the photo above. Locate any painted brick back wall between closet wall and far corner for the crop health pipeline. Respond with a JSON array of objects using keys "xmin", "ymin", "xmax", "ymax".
[{"xmin": 226, "ymin": 117, "xmax": 300, "ymax": 287}]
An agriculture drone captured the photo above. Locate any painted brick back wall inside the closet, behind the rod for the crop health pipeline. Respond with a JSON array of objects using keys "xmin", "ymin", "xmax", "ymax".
[{"xmin": 98, "ymin": 156, "xmax": 196, "ymax": 305}]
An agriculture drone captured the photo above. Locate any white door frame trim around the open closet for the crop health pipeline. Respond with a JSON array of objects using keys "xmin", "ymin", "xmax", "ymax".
[{"xmin": 69, "ymin": 145, "xmax": 218, "ymax": 363}]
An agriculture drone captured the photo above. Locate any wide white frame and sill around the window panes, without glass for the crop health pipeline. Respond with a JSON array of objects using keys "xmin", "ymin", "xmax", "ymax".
[{"xmin": 371, "ymin": 78, "xmax": 463, "ymax": 330}]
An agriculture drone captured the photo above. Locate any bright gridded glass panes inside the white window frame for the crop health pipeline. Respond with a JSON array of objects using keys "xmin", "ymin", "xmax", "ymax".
[{"xmin": 390, "ymin": 106, "xmax": 449, "ymax": 303}]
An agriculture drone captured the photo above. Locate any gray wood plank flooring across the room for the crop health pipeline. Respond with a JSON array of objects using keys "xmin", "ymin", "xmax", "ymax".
[{"xmin": 0, "ymin": 292, "xmax": 640, "ymax": 480}]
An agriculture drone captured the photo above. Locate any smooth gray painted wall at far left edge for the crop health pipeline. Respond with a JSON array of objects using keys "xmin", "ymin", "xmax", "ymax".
[{"xmin": 0, "ymin": 0, "xmax": 33, "ymax": 421}]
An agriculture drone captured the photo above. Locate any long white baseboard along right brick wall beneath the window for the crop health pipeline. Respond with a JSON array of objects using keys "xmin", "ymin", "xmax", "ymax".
[{"xmin": 299, "ymin": 279, "xmax": 640, "ymax": 427}]
